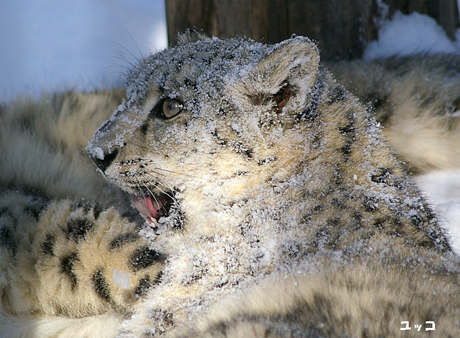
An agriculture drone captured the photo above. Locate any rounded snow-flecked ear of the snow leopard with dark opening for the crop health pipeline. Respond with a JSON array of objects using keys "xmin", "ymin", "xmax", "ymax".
[{"xmin": 245, "ymin": 37, "xmax": 319, "ymax": 113}]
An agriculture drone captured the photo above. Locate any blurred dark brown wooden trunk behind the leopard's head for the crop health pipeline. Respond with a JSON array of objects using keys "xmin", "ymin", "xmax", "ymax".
[{"xmin": 166, "ymin": 0, "xmax": 459, "ymax": 59}]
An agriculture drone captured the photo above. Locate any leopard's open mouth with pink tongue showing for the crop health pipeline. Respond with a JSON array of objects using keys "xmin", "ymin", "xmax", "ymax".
[{"xmin": 131, "ymin": 194, "xmax": 174, "ymax": 228}]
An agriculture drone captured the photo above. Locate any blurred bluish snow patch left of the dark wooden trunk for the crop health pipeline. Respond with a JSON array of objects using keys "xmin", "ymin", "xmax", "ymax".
[{"xmin": 0, "ymin": 0, "xmax": 166, "ymax": 101}]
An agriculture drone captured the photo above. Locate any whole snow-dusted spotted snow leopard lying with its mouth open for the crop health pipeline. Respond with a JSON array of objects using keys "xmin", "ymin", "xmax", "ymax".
[{"xmin": 0, "ymin": 34, "xmax": 460, "ymax": 337}]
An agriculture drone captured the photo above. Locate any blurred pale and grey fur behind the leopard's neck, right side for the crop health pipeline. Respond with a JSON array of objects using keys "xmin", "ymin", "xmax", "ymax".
[{"xmin": 328, "ymin": 54, "xmax": 460, "ymax": 173}]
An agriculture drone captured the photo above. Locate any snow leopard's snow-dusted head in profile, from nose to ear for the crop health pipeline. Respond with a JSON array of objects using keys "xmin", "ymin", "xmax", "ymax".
[{"xmin": 87, "ymin": 38, "xmax": 318, "ymax": 227}]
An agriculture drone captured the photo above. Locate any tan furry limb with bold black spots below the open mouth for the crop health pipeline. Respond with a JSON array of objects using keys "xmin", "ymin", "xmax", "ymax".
[{"xmin": 0, "ymin": 191, "xmax": 166, "ymax": 318}]
